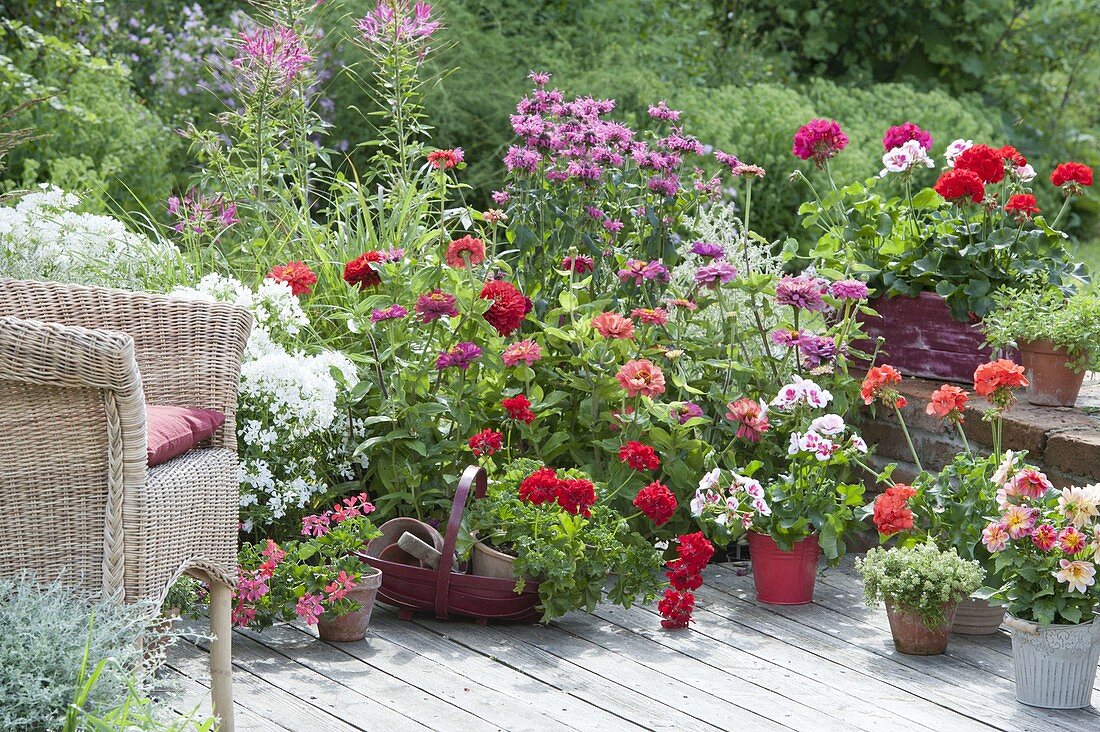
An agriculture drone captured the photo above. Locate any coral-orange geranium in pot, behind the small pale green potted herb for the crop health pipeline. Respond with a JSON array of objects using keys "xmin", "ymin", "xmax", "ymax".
[{"xmin": 862, "ymin": 360, "xmax": 1034, "ymax": 635}]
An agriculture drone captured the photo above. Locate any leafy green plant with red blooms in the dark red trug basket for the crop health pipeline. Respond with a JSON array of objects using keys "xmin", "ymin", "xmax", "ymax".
[{"xmin": 463, "ymin": 458, "xmax": 662, "ymax": 621}]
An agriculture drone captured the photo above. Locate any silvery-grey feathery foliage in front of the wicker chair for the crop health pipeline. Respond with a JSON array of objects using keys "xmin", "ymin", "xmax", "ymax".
[{"xmin": 0, "ymin": 576, "xmax": 151, "ymax": 732}]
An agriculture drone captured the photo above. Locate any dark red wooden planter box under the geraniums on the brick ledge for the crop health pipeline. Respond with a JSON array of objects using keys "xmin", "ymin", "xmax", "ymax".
[{"xmin": 856, "ymin": 293, "xmax": 991, "ymax": 382}]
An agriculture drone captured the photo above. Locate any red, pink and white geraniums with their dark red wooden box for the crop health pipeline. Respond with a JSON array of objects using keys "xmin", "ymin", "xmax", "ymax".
[{"xmin": 795, "ymin": 120, "xmax": 1092, "ymax": 382}]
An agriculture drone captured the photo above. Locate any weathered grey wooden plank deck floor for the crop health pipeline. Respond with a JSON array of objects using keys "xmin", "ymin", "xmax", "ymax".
[{"xmin": 167, "ymin": 556, "xmax": 1100, "ymax": 732}]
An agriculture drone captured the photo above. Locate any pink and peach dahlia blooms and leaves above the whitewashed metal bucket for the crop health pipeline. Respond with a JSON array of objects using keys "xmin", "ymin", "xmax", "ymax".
[{"xmin": 981, "ymin": 477, "xmax": 1100, "ymax": 625}]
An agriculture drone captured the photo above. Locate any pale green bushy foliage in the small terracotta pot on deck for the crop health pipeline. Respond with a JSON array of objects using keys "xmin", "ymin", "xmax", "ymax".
[{"xmin": 856, "ymin": 540, "xmax": 985, "ymax": 627}]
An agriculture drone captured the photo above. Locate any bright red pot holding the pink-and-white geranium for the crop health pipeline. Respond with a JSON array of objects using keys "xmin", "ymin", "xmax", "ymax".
[{"xmin": 748, "ymin": 532, "xmax": 822, "ymax": 605}]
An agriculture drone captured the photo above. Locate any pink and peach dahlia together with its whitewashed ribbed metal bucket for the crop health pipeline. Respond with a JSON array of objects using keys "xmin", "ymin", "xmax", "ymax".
[{"xmin": 983, "ymin": 484, "xmax": 1100, "ymax": 709}]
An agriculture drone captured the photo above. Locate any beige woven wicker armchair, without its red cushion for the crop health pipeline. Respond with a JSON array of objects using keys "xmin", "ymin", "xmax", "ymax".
[{"xmin": 0, "ymin": 278, "xmax": 252, "ymax": 731}]
